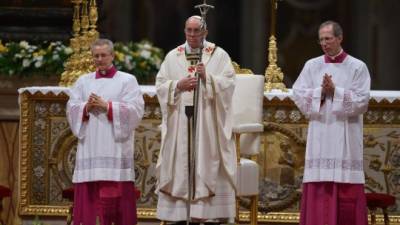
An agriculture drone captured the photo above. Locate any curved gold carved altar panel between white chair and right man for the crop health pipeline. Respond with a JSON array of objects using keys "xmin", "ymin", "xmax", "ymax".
[{"xmin": 258, "ymin": 122, "xmax": 306, "ymax": 213}]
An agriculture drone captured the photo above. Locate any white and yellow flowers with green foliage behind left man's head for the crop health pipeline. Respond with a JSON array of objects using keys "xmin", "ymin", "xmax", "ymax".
[{"xmin": 0, "ymin": 40, "xmax": 164, "ymax": 84}]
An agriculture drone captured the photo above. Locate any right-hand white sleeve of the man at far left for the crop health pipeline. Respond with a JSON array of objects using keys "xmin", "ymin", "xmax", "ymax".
[{"xmin": 112, "ymin": 76, "xmax": 144, "ymax": 141}]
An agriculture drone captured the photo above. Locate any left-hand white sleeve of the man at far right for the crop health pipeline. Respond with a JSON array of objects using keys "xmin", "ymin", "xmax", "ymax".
[{"xmin": 293, "ymin": 62, "xmax": 322, "ymax": 118}]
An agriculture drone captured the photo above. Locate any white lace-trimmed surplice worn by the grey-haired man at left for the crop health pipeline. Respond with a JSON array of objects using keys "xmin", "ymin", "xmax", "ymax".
[{"xmin": 67, "ymin": 71, "xmax": 144, "ymax": 183}]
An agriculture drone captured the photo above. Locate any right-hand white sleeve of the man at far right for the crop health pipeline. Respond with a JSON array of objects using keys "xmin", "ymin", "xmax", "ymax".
[{"xmin": 332, "ymin": 63, "xmax": 371, "ymax": 116}]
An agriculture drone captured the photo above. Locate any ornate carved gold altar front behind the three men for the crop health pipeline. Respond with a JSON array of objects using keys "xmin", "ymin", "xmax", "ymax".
[{"xmin": 18, "ymin": 86, "xmax": 400, "ymax": 224}]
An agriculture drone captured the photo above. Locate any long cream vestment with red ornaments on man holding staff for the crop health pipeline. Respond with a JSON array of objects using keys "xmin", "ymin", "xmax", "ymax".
[{"xmin": 156, "ymin": 42, "xmax": 237, "ymax": 221}]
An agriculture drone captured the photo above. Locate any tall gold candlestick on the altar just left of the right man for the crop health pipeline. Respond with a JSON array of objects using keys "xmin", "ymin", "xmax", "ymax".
[{"xmin": 265, "ymin": 0, "xmax": 287, "ymax": 92}]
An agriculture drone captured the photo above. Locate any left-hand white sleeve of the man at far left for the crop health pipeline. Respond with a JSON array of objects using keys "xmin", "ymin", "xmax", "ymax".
[{"xmin": 67, "ymin": 79, "xmax": 86, "ymax": 139}]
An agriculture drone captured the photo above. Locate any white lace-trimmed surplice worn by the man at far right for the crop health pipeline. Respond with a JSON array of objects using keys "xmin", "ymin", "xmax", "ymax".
[{"xmin": 293, "ymin": 55, "xmax": 371, "ymax": 184}]
